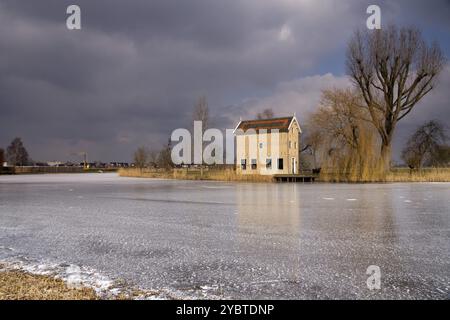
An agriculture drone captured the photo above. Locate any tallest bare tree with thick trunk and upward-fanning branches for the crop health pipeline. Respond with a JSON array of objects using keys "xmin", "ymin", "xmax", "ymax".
[{"xmin": 347, "ymin": 26, "xmax": 445, "ymax": 169}]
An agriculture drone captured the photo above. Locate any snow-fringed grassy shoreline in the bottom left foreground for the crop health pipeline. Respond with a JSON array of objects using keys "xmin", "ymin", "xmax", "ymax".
[{"xmin": 0, "ymin": 258, "xmax": 226, "ymax": 301}]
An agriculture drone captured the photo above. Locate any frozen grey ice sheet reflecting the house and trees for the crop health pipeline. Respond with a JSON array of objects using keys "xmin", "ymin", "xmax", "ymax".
[{"xmin": 0, "ymin": 174, "xmax": 450, "ymax": 299}]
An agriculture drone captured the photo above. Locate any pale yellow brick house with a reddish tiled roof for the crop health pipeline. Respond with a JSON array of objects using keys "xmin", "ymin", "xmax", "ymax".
[{"xmin": 234, "ymin": 114, "xmax": 302, "ymax": 175}]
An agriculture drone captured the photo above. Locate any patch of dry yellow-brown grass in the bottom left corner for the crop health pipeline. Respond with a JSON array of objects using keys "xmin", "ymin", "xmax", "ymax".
[{"xmin": 0, "ymin": 270, "xmax": 98, "ymax": 300}]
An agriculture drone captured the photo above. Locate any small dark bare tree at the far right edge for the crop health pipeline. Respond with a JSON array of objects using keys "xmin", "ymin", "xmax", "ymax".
[{"xmin": 402, "ymin": 120, "xmax": 447, "ymax": 169}]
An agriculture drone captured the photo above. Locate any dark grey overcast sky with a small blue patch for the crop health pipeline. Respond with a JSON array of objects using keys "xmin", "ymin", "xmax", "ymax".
[{"xmin": 0, "ymin": 0, "xmax": 450, "ymax": 161}]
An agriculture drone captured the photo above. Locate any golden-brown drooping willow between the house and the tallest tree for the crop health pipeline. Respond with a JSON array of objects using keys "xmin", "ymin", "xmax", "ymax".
[{"xmin": 308, "ymin": 89, "xmax": 377, "ymax": 181}]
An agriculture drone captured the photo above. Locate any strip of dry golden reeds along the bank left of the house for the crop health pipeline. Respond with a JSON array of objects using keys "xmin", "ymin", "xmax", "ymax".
[{"xmin": 119, "ymin": 169, "xmax": 273, "ymax": 182}]
